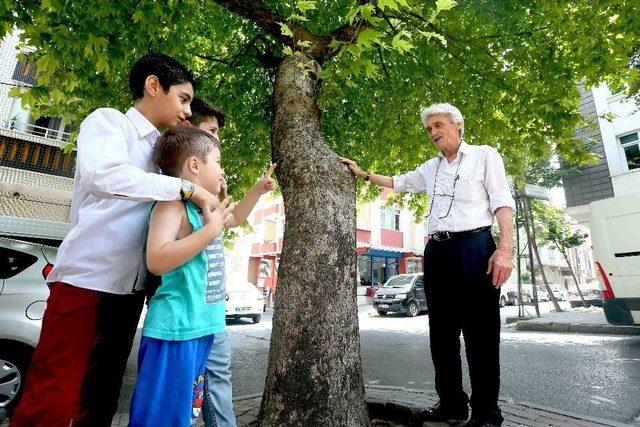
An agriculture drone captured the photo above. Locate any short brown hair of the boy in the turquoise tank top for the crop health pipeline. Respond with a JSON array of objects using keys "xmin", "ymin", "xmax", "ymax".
[{"xmin": 153, "ymin": 125, "xmax": 220, "ymax": 177}]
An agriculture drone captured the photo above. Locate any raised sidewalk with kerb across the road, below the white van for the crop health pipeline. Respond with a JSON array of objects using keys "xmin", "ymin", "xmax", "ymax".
[{"xmin": 515, "ymin": 307, "xmax": 640, "ymax": 335}]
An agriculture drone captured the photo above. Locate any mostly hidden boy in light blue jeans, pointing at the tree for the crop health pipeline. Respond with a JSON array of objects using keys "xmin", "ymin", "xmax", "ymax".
[{"xmin": 189, "ymin": 98, "xmax": 275, "ymax": 427}]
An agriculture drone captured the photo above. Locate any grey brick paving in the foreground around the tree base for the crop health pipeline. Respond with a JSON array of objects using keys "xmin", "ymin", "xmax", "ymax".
[{"xmin": 106, "ymin": 386, "xmax": 623, "ymax": 427}]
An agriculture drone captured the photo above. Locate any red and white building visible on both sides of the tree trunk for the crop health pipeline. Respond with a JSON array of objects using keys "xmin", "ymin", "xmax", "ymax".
[{"xmin": 229, "ymin": 190, "xmax": 426, "ymax": 300}]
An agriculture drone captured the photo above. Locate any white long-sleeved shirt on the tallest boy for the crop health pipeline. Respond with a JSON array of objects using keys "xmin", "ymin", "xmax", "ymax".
[{"xmin": 47, "ymin": 108, "xmax": 181, "ymax": 294}]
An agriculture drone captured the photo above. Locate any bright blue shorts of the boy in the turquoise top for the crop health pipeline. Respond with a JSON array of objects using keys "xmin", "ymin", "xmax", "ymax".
[{"xmin": 129, "ymin": 335, "xmax": 214, "ymax": 427}]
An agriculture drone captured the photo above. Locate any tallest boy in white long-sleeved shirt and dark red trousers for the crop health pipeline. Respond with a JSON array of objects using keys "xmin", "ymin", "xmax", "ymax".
[{"xmin": 11, "ymin": 54, "xmax": 220, "ymax": 426}]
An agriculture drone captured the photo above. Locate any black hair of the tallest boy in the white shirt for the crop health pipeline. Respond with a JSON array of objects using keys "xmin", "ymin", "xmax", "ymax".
[{"xmin": 129, "ymin": 53, "xmax": 196, "ymax": 100}]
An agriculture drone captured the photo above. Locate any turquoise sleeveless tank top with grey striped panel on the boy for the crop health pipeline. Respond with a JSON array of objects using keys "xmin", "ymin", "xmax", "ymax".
[{"xmin": 142, "ymin": 202, "xmax": 225, "ymax": 341}]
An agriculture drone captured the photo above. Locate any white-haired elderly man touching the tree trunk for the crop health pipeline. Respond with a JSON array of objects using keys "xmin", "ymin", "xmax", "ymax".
[{"xmin": 340, "ymin": 104, "xmax": 515, "ymax": 426}]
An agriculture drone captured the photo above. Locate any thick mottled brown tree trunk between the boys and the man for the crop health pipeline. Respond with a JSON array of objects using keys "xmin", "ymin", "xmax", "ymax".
[{"xmin": 259, "ymin": 55, "xmax": 370, "ymax": 426}]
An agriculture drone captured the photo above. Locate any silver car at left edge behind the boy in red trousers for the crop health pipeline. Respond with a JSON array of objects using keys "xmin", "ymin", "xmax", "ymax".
[{"xmin": 0, "ymin": 237, "xmax": 57, "ymax": 415}]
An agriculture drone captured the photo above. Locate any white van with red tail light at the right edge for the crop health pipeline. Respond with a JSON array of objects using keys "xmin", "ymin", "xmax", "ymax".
[{"xmin": 589, "ymin": 193, "xmax": 640, "ymax": 325}]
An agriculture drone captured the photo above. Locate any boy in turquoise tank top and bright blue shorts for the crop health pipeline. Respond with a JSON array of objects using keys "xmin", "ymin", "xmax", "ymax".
[{"xmin": 129, "ymin": 126, "xmax": 233, "ymax": 427}]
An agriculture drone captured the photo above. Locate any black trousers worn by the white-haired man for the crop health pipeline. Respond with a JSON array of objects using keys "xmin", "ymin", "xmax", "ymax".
[{"xmin": 424, "ymin": 230, "xmax": 500, "ymax": 417}]
